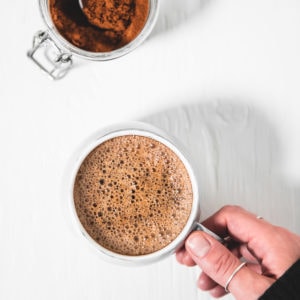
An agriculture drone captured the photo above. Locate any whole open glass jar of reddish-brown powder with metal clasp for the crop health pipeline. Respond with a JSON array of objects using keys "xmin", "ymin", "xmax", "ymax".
[{"xmin": 27, "ymin": 0, "xmax": 159, "ymax": 79}]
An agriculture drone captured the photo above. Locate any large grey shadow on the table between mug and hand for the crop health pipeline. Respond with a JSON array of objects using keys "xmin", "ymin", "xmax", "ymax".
[{"xmin": 142, "ymin": 101, "xmax": 300, "ymax": 231}]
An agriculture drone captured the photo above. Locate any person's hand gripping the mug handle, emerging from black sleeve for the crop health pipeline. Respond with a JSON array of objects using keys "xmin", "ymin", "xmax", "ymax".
[{"xmin": 176, "ymin": 206, "xmax": 300, "ymax": 300}]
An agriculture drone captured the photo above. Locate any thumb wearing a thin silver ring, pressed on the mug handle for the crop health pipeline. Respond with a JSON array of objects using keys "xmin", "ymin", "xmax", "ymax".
[{"xmin": 185, "ymin": 231, "xmax": 269, "ymax": 299}]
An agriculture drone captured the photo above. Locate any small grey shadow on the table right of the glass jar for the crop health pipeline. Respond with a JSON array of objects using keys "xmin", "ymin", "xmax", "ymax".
[{"xmin": 153, "ymin": 0, "xmax": 214, "ymax": 35}]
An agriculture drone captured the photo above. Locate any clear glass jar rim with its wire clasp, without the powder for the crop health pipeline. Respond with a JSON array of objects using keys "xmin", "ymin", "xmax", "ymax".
[{"xmin": 27, "ymin": 0, "xmax": 159, "ymax": 79}]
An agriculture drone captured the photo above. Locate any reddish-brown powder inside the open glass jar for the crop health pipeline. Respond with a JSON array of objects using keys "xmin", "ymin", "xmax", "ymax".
[{"xmin": 49, "ymin": 0, "xmax": 149, "ymax": 52}]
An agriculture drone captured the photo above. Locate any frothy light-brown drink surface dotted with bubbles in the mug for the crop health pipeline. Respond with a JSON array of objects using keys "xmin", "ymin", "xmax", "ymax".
[{"xmin": 73, "ymin": 135, "xmax": 193, "ymax": 255}]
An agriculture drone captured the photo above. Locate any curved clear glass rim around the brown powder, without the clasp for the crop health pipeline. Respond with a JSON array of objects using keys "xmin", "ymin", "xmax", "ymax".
[{"xmin": 39, "ymin": 0, "xmax": 160, "ymax": 61}]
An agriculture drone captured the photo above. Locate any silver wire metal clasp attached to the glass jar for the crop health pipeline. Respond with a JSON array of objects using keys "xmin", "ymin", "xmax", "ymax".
[{"xmin": 27, "ymin": 31, "xmax": 73, "ymax": 80}]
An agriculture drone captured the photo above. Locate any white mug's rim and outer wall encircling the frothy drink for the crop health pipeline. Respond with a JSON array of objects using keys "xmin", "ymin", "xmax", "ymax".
[{"xmin": 68, "ymin": 122, "xmax": 200, "ymax": 265}]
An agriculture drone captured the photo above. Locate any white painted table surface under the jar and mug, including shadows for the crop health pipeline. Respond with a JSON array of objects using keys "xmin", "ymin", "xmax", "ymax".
[{"xmin": 0, "ymin": 0, "xmax": 300, "ymax": 300}]
